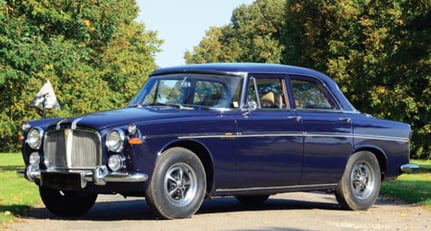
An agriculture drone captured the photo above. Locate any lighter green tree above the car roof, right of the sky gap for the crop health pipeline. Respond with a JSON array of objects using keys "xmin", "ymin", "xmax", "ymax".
[{"xmin": 185, "ymin": 0, "xmax": 285, "ymax": 63}]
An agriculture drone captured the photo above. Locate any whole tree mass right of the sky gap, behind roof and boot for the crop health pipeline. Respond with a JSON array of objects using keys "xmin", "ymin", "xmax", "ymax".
[{"xmin": 185, "ymin": 0, "xmax": 431, "ymax": 159}]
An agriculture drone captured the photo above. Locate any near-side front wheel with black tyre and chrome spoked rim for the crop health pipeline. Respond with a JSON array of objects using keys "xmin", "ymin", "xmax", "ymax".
[{"xmin": 146, "ymin": 147, "xmax": 206, "ymax": 219}]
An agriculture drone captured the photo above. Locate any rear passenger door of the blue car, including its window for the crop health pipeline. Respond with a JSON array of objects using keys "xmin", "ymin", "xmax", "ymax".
[{"xmin": 290, "ymin": 76, "xmax": 353, "ymax": 184}]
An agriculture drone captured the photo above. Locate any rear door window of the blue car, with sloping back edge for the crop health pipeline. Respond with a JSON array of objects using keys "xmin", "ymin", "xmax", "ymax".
[{"xmin": 291, "ymin": 79, "xmax": 336, "ymax": 110}]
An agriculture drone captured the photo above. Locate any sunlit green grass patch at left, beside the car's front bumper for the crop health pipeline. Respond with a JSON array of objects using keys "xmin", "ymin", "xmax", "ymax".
[{"xmin": 0, "ymin": 153, "xmax": 40, "ymax": 229}]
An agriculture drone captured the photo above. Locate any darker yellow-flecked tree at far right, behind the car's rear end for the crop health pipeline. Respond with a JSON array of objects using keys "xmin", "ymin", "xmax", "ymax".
[{"xmin": 284, "ymin": 0, "xmax": 431, "ymax": 158}]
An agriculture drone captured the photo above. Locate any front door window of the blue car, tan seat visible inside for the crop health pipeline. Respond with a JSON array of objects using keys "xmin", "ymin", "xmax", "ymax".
[{"xmin": 248, "ymin": 78, "xmax": 288, "ymax": 109}]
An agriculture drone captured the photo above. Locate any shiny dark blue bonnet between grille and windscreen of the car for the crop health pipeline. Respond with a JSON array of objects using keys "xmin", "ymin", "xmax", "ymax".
[{"xmin": 56, "ymin": 108, "xmax": 214, "ymax": 130}]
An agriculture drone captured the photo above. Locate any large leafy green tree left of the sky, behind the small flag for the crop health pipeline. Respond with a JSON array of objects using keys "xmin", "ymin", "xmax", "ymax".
[{"xmin": 0, "ymin": 0, "xmax": 162, "ymax": 151}]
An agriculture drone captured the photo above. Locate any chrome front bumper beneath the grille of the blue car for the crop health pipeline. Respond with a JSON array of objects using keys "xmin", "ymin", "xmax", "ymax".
[{"xmin": 17, "ymin": 165, "xmax": 148, "ymax": 188}]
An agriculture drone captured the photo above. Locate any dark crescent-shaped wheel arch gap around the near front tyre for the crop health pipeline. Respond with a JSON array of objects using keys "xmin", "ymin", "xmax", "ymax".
[{"xmin": 163, "ymin": 140, "xmax": 214, "ymax": 195}]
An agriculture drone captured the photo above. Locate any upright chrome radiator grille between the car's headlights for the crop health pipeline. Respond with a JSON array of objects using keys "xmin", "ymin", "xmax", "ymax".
[{"xmin": 44, "ymin": 129, "xmax": 101, "ymax": 169}]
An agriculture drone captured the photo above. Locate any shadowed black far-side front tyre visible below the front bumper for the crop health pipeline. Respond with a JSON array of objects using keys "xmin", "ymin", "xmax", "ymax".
[{"xmin": 39, "ymin": 187, "xmax": 97, "ymax": 217}]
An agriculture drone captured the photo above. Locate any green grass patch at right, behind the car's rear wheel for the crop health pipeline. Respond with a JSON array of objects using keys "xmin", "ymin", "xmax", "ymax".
[{"xmin": 381, "ymin": 160, "xmax": 431, "ymax": 208}]
